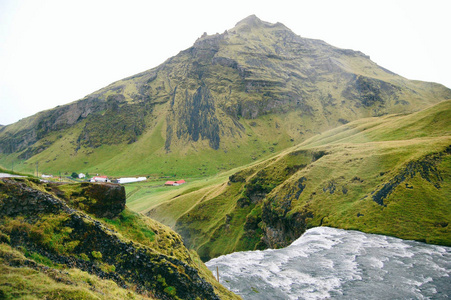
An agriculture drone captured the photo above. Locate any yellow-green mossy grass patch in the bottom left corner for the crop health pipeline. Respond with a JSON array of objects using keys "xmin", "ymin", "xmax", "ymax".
[{"xmin": 0, "ymin": 243, "xmax": 148, "ymax": 300}]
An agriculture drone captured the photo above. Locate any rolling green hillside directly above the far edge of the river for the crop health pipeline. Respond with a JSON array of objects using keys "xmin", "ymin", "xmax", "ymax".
[{"xmin": 128, "ymin": 101, "xmax": 451, "ymax": 259}]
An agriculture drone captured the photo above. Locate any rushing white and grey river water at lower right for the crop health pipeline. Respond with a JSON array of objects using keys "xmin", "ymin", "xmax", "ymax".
[{"xmin": 207, "ymin": 227, "xmax": 451, "ymax": 300}]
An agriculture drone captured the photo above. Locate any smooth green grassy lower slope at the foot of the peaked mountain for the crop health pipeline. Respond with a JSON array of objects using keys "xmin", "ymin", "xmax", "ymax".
[{"xmin": 0, "ymin": 109, "xmax": 300, "ymax": 177}]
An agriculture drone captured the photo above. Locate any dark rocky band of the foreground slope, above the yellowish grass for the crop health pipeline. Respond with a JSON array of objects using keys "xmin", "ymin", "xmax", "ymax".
[{"xmin": 0, "ymin": 179, "xmax": 233, "ymax": 299}]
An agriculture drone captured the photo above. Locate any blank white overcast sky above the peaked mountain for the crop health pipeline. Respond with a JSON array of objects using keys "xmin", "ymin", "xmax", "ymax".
[{"xmin": 0, "ymin": 0, "xmax": 451, "ymax": 125}]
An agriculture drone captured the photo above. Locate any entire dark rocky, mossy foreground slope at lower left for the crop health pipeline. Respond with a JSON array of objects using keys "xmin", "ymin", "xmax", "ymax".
[{"xmin": 0, "ymin": 178, "xmax": 239, "ymax": 299}]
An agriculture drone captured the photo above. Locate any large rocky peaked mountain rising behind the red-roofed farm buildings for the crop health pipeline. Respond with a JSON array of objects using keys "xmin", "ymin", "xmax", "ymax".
[{"xmin": 0, "ymin": 16, "xmax": 451, "ymax": 176}]
